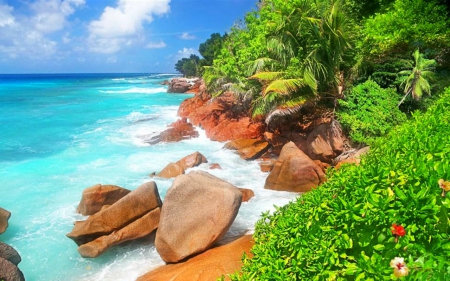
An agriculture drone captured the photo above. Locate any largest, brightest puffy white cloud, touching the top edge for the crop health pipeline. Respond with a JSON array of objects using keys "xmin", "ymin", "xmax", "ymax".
[{"xmin": 88, "ymin": 0, "xmax": 170, "ymax": 53}]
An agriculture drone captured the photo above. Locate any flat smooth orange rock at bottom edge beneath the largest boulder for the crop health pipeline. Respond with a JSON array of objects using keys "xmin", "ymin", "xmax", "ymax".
[{"xmin": 137, "ymin": 235, "xmax": 254, "ymax": 281}]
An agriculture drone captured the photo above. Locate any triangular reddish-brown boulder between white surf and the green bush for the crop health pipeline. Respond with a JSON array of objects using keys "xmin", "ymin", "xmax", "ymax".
[{"xmin": 264, "ymin": 142, "xmax": 325, "ymax": 192}]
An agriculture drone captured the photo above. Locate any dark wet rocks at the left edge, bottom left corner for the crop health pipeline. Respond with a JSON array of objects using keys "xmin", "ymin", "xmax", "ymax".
[{"xmin": 0, "ymin": 208, "xmax": 25, "ymax": 281}]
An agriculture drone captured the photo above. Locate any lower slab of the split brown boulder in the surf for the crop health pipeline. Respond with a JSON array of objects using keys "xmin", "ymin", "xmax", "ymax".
[{"xmin": 78, "ymin": 207, "xmax": 160, "ymax": 258}]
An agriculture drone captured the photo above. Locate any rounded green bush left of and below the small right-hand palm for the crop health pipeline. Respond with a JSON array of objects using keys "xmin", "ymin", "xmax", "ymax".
[{"xmin": 338, "ymin": 80, "xmax": 406, "ymax": 144}]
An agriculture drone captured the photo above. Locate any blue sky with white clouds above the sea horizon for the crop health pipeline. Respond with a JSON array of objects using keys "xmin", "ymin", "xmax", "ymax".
[{"xmin": 0, "ymin": 0, "xmax": 257, "ymax": 74}]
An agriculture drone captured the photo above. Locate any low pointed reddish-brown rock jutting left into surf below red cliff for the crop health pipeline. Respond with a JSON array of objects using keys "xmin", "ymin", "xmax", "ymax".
[{"xmin": 145, "ymin": 118, "xmax": 199, "ymax": 144}]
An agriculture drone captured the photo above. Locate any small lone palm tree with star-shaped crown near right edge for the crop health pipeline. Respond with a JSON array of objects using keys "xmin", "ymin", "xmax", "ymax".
[{"xmin": 398, "ymin": 49, "xmax": 436, "ymax": 106}]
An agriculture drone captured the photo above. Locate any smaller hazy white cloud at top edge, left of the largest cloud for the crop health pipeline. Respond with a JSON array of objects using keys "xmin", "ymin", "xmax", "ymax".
[{"xmin": 31, "ymin": 0, "xmax": 85, "ymax": 33}]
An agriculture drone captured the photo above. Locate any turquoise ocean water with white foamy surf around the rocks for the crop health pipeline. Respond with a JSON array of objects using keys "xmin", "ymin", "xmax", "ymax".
[{"xmin": 0, "ymin": 74, "xmax": 295, "ymax": 281}]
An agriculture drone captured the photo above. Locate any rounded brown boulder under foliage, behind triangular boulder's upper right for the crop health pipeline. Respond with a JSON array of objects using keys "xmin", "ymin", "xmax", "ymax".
[{"xmin": 306, "ymin": 122, "xmax": 344, "ymax": 164}]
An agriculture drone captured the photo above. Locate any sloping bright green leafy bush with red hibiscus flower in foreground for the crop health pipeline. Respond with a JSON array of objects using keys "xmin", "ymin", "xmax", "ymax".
[{"xmin": 231, "ymin": 89, "xmax": 450, "ymax": 281}]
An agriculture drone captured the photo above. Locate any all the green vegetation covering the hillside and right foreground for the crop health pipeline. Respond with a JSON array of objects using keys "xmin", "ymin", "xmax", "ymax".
[{"xmin": 173, "ymin": 0, "xmax": 450, "ymax": 280}]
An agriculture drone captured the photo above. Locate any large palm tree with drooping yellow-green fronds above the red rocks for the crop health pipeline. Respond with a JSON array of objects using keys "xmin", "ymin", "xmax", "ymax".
[{"xmin": 250, "ymin": 0, "xmax": 350, "ymax": 123}]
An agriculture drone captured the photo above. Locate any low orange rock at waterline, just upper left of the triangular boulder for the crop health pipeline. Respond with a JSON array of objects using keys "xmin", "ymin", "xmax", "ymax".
[{"xmin": 223, "ymin": 139, "xmax": 270, "ymax": 160}]
